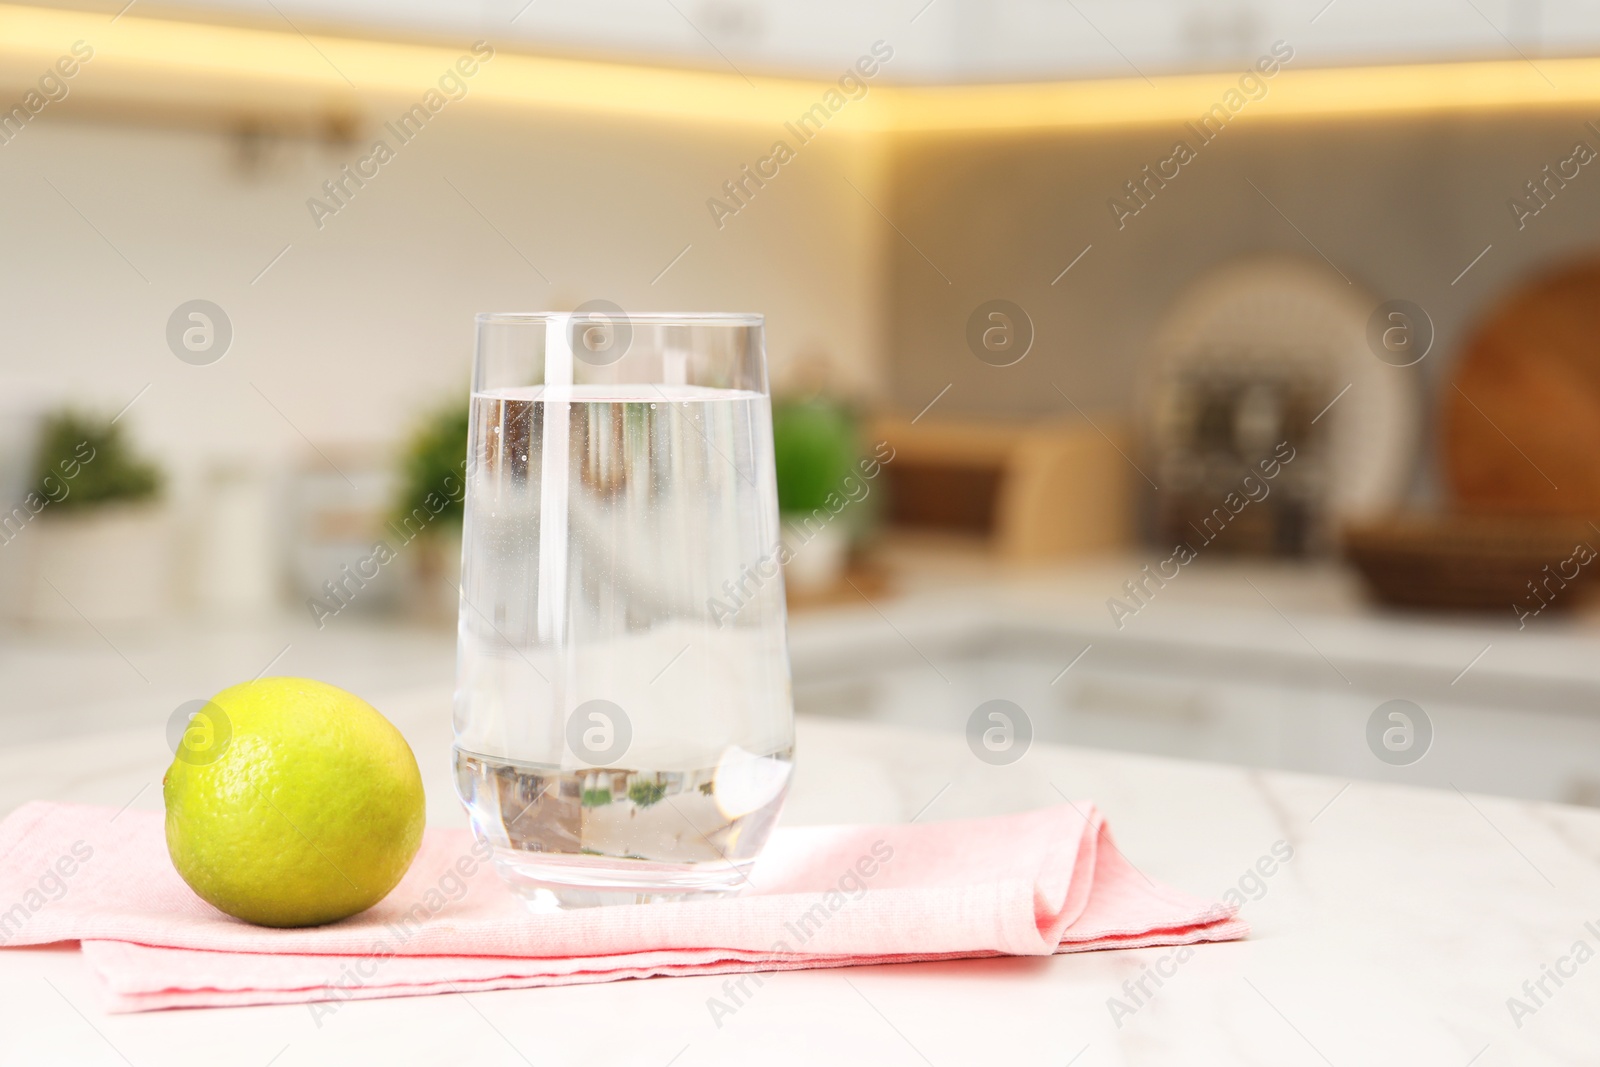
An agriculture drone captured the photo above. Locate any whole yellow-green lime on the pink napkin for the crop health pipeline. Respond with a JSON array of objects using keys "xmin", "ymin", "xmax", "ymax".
[{"xmin": 162, "ymin": 678, "xmax": 422, "ymax": 926}]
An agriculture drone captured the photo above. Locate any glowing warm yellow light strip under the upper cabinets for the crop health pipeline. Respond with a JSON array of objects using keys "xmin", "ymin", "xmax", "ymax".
[{"xmin": 0, "ymin": 5, "xmax": 1600, "ymax": 138}]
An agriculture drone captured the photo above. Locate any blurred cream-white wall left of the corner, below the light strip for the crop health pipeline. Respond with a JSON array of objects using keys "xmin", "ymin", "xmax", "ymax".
[{"xmin": 0, "ymin": 101, "xmax": 890, "ymax": 508}]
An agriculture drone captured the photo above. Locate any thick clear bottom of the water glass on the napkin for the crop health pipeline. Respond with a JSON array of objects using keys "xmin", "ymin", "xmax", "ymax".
[{"xmin": 494, "ymin": 848, "xmax": 755, "ymax": 912}]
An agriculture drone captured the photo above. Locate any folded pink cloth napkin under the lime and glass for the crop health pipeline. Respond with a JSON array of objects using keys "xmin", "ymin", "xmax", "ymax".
[{"xmin": 0, "ymin": 803, "xmax": 1250, "ymax": 1011}]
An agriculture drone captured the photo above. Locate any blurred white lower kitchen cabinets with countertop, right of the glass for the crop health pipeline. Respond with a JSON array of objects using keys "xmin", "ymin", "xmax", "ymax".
[{"xmin": 794, "ymin": 577, "xmax": 1600, "ymax": 806}]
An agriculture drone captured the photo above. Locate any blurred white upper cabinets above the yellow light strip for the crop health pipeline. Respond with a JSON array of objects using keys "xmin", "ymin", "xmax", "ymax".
[{"xmin": 144, "ymin": 0, "xmax": 1600, "ymax": 83}]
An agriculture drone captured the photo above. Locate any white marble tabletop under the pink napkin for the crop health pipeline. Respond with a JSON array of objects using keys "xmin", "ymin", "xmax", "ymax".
[{"xmin": 0, "ymin": 689, "xmax": 1600, "ymax": 1067}]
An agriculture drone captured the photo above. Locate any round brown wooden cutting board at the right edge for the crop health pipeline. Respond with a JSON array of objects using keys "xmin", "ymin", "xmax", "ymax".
[{"xmin": 1440, "ymin": 259, "xmax": 1600, "ymax": 518}]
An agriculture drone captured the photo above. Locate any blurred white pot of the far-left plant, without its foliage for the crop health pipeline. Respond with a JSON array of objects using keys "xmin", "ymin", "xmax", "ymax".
[{"xmin": 13, "ymin": 504, "xmax": 173, "ymax": 625}]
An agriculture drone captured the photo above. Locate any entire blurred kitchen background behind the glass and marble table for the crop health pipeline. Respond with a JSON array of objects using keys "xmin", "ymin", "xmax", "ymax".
[{"xmin": 0, "ymin": 0, "xmax": 1600, "ymax": 805}]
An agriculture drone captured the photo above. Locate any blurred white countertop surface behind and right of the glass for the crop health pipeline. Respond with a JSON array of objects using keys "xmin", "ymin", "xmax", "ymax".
[{"xmin": 792, "ymin": 549, "xmax": 1600, "ymax": 700}]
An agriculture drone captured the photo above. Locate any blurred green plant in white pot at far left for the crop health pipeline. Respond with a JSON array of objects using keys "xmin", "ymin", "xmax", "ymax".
[{"xmin": 10, "ymin": 410, "xmax": 173, "ymax": 624}]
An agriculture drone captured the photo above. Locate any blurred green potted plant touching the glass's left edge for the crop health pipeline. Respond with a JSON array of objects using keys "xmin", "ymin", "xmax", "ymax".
[{"xmin": 386, "ymin": 402, "xmax": 469, "ymax": 621}]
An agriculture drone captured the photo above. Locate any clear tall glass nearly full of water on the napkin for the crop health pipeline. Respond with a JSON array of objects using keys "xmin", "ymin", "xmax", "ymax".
[{"xmin": 454, "ymin": 306, "xmax": 794, "ymax": 907}]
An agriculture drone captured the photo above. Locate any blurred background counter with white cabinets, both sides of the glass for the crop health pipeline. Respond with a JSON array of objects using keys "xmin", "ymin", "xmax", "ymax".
[{"xmin": 0, "ymin": 547, "xmax": 1600, "ymax": 803}]
